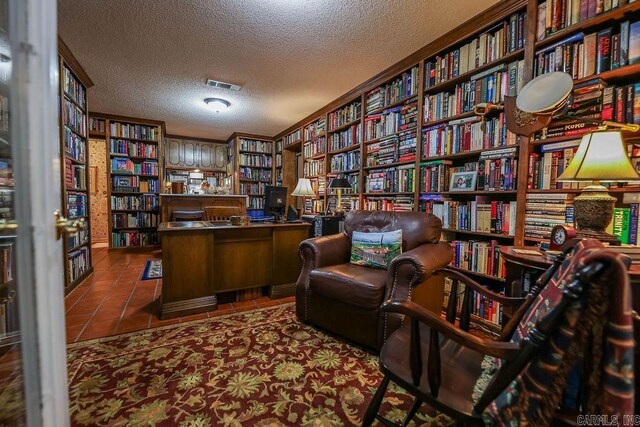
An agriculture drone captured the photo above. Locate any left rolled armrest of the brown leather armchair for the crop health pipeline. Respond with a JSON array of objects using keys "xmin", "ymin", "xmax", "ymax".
[{"xmin": 298, "ymin": 233, "xmax": 351, "ymax": 268}]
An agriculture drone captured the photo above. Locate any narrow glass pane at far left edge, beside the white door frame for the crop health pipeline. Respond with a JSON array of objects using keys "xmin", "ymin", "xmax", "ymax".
[{"xmin": 0, "ymin": 0, "xmax": 26, "ymax": 426}]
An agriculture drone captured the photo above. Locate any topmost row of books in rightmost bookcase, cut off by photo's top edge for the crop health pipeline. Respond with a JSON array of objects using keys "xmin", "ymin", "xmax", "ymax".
[{"xmin": 536, "ymin": 0, "xmax": 635, "ymax": 40}]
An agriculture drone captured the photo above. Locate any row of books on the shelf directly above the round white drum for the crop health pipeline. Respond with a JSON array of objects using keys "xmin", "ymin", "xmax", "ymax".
[{"xmin": 534, "ymin": 21, "xmax": 640, "ymax": 79}]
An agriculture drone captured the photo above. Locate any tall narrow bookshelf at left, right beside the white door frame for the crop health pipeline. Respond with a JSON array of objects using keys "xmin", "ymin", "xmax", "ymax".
[{"xmin": 58, "ymin": 40, "xmax": 93, "ymax": 293}]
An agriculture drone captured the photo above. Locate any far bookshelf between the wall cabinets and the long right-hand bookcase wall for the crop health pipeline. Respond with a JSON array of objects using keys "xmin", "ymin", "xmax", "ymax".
[{"xmin": 227, "ymin": 133, "xmax": 277, "ymax": 214}]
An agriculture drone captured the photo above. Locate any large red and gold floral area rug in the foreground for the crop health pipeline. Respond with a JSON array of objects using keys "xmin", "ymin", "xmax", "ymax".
[{"xmin": 67, "ymin": 304, "xmax": 450, "ymax": 427}]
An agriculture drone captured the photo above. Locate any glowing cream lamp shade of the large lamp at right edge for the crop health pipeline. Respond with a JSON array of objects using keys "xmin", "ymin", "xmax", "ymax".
[{"xmin": 558, "ymin": 131, "xmax": 639, "ymax": 182}]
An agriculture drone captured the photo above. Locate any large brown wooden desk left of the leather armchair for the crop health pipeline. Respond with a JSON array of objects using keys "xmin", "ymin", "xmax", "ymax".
[{"xmin": 158, "ymin": 221, "xmax": 310, "ymax": 319}]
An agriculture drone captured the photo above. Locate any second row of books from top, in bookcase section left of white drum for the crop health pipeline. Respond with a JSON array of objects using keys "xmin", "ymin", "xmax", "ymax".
[{"xmin": 423, "ymin": 60, "xmax": 524, "ymax": 123}]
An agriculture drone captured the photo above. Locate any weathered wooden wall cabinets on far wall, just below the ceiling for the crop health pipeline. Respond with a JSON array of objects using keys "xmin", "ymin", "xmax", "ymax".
[{"xmin": 165, "ymin": 137, "xmax": 227, "ymax": 171}]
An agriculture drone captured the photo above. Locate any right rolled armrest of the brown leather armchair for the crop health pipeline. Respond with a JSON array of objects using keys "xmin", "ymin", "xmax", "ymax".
[{"xmin": 389, "ymin": 242, "xmax": 453, "ymax": 290}]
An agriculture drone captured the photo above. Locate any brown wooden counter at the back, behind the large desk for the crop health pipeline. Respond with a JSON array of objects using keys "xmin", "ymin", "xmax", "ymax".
[{"xmin": 160, "ymin": 194, "xmax": 247, "ymax": 222}]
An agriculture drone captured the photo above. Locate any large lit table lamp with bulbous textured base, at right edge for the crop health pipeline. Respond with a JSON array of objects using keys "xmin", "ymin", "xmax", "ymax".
[{"xmin": 558, "ymin": 130, "xmax": 639, "ymax": 241}]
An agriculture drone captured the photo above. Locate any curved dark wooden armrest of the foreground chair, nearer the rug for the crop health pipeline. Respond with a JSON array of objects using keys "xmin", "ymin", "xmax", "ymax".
[{"xmin": 381, "ymin": 300, "xmax": 520, "ymax": 360}]
